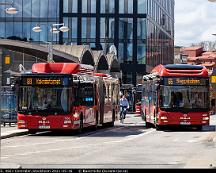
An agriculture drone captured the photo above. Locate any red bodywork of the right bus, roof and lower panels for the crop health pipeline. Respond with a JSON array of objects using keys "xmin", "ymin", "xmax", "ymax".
[{"xmin": 141, "ymin": 65, "xmax": 209, "ymax": 126}]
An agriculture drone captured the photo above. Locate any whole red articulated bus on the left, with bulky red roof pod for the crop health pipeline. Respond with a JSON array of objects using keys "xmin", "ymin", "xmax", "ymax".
[{"xmin": 17, "ymin": 63, "xmax": 120, "ymax": 134}]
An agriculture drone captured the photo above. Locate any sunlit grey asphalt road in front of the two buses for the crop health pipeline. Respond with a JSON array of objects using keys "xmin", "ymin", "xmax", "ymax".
[{"xmin": 1, "ymin": 115, "xmax": 216, "ymax": 169}]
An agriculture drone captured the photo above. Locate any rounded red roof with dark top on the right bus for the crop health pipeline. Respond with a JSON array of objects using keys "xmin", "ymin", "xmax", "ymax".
[{"xmin": 151, "ymin": 64, "xmax": 208, "ymax": 77}]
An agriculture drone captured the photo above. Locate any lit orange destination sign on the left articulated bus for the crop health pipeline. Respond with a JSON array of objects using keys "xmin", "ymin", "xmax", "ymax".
[{"xmin": 22, "ymin": 77, "xmax": 68, "ymax": 86}]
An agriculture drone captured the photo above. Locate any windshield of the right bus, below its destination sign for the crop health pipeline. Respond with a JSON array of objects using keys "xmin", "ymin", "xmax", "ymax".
[{"xmin": 160, "ymin": 86, "xmax": 209, "ymax": 110}]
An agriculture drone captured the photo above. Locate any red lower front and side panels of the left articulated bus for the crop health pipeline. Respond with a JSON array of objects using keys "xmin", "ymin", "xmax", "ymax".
[{"xmin": 17, "ymin": 107, "xmax": 96, "ymax": 130}]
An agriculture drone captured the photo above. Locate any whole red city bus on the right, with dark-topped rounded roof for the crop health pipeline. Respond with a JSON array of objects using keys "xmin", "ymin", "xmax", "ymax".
[{"xmin": 141, "ymin": 64, "xmax": 209, "ymax": 130}]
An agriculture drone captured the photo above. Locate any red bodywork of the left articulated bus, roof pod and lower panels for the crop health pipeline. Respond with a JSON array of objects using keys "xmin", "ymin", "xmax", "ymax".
[{"xmin": 17, "ymin": 63, "xmax": 116, "ymax": 130}]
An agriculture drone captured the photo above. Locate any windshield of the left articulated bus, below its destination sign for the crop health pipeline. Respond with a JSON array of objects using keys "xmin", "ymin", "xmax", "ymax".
[{"xmin": 18, "ymin": 87, "xmax": 70, "ymax": 114}]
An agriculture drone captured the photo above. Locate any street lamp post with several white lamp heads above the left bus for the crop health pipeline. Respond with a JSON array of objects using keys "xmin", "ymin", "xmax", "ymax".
[{"xmin": 32, "ymin": 23, "xmax": 69, "ymax": 62}]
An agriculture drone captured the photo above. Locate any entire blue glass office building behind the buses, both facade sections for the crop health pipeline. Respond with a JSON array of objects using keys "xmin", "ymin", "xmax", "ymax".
[{"xmin": 0, "ymin": 0, "xmax": 175, "ymax": 85}]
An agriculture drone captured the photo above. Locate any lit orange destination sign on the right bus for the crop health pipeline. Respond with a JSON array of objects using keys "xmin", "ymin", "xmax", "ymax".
[{"xmin": 164, "ymin": 77, "xmax": 207, "ymax": 85}]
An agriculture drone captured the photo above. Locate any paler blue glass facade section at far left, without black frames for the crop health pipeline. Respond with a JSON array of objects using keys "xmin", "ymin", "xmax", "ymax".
[{"xmin": 0, "ymin": 0, "xmax": 60, "ymax": 42}]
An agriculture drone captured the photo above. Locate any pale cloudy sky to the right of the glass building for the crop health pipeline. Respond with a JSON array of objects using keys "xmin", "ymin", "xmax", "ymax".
[{"xmin": 175, "ymin": 0, "xmax": 216, "ymax": 46}]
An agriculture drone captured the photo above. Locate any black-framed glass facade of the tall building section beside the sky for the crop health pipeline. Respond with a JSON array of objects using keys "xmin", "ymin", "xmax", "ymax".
[{"xmin": 62, "ymin": 0, "xmax": 175, "ymax": 84}]
